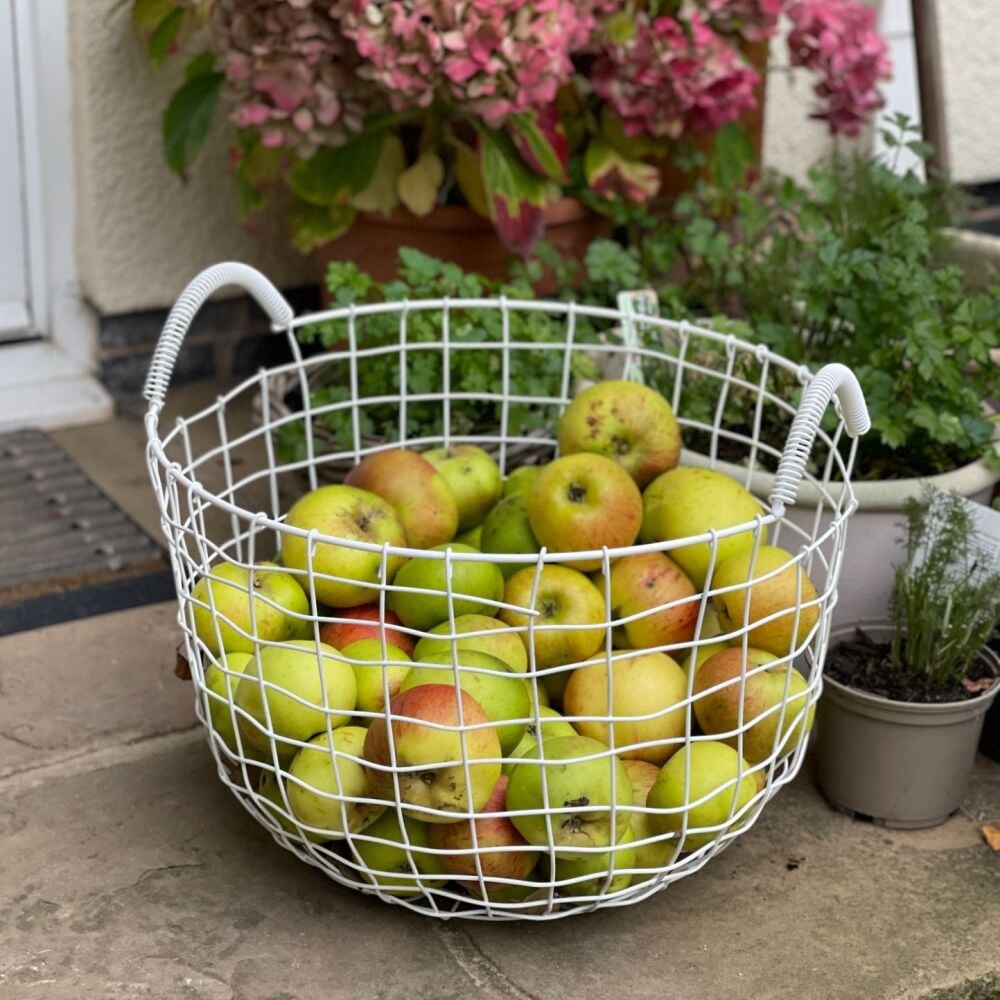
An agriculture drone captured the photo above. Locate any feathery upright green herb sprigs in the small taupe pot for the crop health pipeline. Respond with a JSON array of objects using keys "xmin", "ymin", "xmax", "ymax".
[{"xmin": 891, "ymin": 488, "xmax": 1000, "ymax": 685}]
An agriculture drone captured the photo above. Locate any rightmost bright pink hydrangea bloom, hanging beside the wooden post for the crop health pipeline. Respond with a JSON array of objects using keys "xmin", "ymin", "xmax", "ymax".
[{"xmin": 788, "ymin": 0, "xmax": 892, "ymax": 136}]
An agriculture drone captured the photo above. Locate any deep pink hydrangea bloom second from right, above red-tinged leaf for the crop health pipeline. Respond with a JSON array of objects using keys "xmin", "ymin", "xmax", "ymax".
[{"xmin": 592, "ymin": 13, "xmax": 760, "ymax": 139}]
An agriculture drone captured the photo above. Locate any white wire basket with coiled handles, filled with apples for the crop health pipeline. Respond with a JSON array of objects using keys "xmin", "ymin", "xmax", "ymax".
[{"xmin": 145, "ymin": 264, "xmax": 868, "ymax": 920}]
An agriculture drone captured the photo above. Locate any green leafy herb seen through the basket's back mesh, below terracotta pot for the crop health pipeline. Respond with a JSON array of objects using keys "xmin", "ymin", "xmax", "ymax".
[{"xmin": 279, "ymin": 248, "xmax": 593, "ymax": 460}]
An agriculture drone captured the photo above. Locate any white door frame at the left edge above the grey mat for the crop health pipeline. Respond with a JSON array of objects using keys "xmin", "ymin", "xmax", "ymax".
[{"xmin": 0, "ymin": 0, "xmax": 113, "ymax": 430}]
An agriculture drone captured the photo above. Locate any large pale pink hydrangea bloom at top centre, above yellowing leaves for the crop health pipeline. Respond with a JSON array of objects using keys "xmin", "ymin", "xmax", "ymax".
[{"xmin": 334, "ymin": 0, "xmax": 594, "ymax": 126}]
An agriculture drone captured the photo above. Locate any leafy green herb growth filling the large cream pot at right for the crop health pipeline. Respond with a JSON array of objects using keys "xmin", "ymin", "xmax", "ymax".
[{"xmin": 589, "ymin": 118, "xmax": 1000, "ymax": 479}]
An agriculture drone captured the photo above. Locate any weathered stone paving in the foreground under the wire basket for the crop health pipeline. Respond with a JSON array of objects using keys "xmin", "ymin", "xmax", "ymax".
[{"xmin": 0, "ymin": 712, "xmax": 1000, "ymax": 1000}]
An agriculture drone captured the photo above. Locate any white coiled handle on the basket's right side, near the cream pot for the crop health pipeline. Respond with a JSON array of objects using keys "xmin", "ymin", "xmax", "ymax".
[{"xmin": 769, "ymin": 364, "xmax": 872, "ymax": 517}]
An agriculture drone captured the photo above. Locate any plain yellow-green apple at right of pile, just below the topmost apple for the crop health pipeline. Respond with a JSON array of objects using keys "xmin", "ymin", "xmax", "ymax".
[{"xmin": 639, "ymin": 466, "xmax": 767, "ymax": 590}]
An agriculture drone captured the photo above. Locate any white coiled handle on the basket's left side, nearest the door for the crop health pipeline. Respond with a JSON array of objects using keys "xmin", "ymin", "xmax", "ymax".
[{"xmin": 142, "ymin": 261, "xmax": 295, "ymax": 411}]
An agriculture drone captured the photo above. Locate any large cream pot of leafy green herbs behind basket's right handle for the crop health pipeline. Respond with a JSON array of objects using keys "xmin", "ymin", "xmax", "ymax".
[{"xmin": 587, "ymin": 118, "xmax": 1000, "ymax": 621}]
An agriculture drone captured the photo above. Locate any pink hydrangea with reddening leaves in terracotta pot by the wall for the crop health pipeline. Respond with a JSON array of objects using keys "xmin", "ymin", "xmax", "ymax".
[{"xmin": 134, "ymin": 0, "xmax": 888, "ymax": 280}]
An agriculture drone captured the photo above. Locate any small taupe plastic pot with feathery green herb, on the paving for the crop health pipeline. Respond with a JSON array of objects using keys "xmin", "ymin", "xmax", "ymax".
[{"xmin": 817, "ymin": 491, "xmax": 1000, "ymax": 828}]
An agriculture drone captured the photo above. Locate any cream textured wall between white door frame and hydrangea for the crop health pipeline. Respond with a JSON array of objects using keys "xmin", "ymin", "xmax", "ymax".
[{"xmin": 71, "ymin": 0, "xmax": 311, "ymax": 314}]
